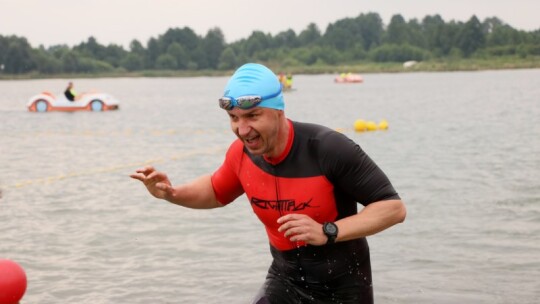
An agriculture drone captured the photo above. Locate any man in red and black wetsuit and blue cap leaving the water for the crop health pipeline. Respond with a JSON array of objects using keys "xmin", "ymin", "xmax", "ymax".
[{"xmin": 131, "ymin": 63, "xmax": 406, "ymax": 304}]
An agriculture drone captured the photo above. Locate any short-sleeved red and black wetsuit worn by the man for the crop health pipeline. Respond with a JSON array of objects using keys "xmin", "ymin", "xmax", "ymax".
[{"xmin": 212, "ymin": 121, "xmax": 399, "ymax": 304}]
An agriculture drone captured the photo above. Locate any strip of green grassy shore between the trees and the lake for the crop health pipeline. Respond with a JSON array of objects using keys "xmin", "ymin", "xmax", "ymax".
[{"xmin": 0, "ymin": 56, "xmax": 540, "ymax": 80}]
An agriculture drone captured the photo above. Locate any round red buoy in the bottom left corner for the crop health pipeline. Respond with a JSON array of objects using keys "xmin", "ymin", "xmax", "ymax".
[{"xmin": 0, "ymin": 259, "xmax": 26, "ymax": 304}]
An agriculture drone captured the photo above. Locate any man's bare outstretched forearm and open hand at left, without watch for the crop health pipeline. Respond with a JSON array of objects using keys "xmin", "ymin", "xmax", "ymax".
[{"xmin": 130, "ymin": 166, "xmax": 223, "ymax": 209}]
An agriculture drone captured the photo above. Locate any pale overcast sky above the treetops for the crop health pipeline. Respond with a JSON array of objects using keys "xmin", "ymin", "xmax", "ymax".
[{"xmin": 0, "ymin": 0, "xmax": 540, "ymax": 47}]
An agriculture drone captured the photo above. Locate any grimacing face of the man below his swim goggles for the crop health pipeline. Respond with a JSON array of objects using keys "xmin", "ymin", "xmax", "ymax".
[{"xmin": 227, "ymin": 107, "xmax": 283, "ymax": 157}]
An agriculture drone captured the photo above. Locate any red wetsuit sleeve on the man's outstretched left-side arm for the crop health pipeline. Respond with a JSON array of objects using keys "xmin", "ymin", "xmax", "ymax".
[{"xmin": 211, "ymin": 141, "xmax": 244, "ymax": 205}]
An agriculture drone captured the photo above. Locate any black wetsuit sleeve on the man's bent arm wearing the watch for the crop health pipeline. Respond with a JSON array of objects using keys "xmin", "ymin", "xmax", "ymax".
[{"xmin": 320, "ymin": 132, "xmax": 399, "ymax": 206}]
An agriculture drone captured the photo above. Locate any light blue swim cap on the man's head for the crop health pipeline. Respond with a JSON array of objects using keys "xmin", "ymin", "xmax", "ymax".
[{"xmin": 223, "ymin": 63, "xmax": 285, "ymax": 110}]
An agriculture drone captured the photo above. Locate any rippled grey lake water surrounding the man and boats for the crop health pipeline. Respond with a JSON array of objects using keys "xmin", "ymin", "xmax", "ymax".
[{"xmin": 0, "ymin": 70, "xmax": 540, "ymax": 304}]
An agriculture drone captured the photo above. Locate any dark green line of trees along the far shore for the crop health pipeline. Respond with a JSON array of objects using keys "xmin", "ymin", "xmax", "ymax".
[{"xmin": 0, "ymin": 13, "xmax": 540, "ymax": 75}]
